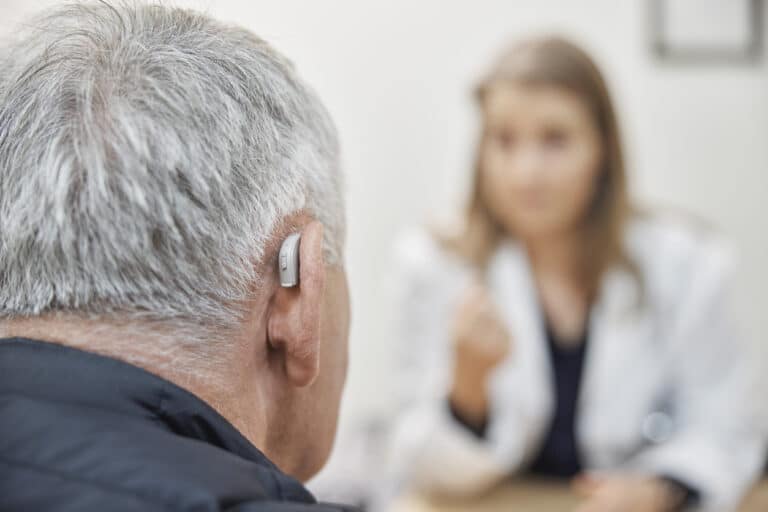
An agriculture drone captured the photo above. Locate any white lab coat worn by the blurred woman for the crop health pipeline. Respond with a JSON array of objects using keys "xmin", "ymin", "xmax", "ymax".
[{"xmin": 393, "ymin": 218, "xmax": 768, "ymax": 511}]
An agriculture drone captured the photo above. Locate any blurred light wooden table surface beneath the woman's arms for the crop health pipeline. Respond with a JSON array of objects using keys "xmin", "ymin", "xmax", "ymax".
[{"xmin": 391, "ymin": 480, "xmax": 768, "ymax": 512}]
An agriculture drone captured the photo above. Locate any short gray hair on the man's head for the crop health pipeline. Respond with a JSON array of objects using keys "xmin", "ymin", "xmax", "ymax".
[{"xmin": 0, "ymin": 2, "xmax": 344, "ymax": 340}]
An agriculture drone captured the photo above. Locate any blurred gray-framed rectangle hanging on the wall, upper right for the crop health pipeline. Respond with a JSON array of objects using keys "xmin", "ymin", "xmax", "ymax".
[{"xmin": 649, "ymin": 0, "xmax": 764, "ymax": 64}]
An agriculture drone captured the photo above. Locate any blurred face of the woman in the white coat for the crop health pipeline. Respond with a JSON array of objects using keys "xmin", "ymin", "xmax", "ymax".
[{"xmin": 480, "ymin": 83, "xmax": 602, "ymax": 238}]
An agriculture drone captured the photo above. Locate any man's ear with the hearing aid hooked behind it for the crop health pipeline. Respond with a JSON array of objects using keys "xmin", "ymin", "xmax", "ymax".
[{"xmin": 267, "ymin": 221, "xmax": 325, "ymax": 387}]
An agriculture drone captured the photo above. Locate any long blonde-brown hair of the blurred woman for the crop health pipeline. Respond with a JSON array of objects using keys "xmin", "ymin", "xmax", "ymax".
[{"xmin": 438, "ymin": 38, "xmax": 642, "ymax": 297}]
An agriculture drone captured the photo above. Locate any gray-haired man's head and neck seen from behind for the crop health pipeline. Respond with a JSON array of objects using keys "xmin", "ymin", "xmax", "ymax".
[{"xmin": 0, "ymin": 3, "xmax": 349, "ymax": 477}]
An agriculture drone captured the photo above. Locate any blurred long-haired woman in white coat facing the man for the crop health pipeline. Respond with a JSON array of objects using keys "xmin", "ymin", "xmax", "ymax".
[{"xmin": 395, "ymin": 39, "xmax": 766, "ymax": 512}]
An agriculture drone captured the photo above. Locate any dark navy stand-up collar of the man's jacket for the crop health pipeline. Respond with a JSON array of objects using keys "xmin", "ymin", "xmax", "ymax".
[{"xmin": 0, "ymin": 338, "xmax": 315, "ymax": 502}]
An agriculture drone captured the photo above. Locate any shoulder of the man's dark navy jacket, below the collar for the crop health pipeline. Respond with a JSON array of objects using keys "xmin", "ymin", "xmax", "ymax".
[{"xmin": 0, "ymin": 395, "xmax": 352, "ymax": 512}]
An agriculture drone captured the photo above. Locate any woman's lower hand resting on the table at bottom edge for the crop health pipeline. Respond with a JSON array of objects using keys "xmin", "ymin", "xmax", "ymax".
[{"xmin": 574, "ymin": 475, "xmax": 685, "ymax": 512}]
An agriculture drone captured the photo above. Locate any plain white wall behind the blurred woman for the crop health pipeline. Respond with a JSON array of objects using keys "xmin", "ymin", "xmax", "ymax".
[{"xmin": 0, "ymin": 0, "xmax": 768, "ymax": 419}]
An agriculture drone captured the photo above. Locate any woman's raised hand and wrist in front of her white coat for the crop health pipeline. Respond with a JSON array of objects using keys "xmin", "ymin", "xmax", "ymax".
[{"xmin": 450, "ymin": 286, "xmax": 511, "ymax": 427}]
